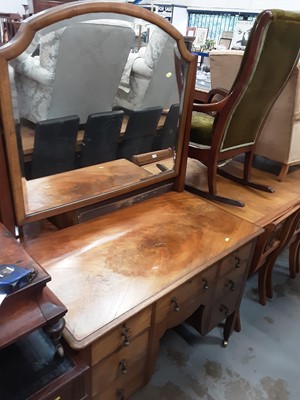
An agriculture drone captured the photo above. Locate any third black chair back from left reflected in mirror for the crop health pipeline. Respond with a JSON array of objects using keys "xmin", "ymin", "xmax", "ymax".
[{"xmin": 118, "ymin": 107, "xmax": 162, "ymax": 161}]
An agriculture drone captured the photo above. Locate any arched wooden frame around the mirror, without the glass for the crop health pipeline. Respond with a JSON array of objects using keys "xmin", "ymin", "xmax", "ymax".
[{"xmin": 0, "ymin": 1, "xmax": 197, "ymax": 226}]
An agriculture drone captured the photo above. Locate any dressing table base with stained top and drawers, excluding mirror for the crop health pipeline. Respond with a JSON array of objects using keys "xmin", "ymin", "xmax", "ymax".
[{"xmin": 25, "ymin": 192, "xmax": 262, "ymax": 400}]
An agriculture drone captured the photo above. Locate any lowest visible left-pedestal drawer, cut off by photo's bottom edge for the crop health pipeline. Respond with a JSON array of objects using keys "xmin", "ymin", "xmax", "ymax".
[{"xmin": 92, "ymin": 373, "xmax": 145, "ymax": 400}]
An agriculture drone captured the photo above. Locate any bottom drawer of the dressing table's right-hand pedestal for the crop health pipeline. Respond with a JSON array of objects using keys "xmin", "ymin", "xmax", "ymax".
[{"xmin": 203, "ymin": 284, "xmax": 243, "ymax": 334}]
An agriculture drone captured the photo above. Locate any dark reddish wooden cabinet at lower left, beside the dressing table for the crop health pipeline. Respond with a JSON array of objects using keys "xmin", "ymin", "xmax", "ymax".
[{"xmin": 0, "ymin": 224, "xmax": 88, "ymax": 400}]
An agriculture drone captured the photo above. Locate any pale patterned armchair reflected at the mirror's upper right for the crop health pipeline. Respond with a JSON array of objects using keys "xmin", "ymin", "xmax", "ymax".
[{"xmin": 115, "ymin": 27, "xmax": 179, "ymax": 110}]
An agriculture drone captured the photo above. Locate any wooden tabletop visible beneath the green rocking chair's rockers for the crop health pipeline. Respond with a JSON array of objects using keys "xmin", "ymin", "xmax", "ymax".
[{"xmin": 186, "ymin": 159, "xmax": 300, "ymax": 227}]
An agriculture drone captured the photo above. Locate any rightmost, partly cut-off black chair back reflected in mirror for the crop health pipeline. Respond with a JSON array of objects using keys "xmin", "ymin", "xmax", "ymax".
[{"xmin": 153, "ymin": 104, "xmax": 180, "ymax": 151}]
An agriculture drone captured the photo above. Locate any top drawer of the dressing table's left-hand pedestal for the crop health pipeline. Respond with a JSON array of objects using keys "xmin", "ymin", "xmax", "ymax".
[{"xmin": 91, "ymin": 307, "xmax": 152, "ymax": 365}]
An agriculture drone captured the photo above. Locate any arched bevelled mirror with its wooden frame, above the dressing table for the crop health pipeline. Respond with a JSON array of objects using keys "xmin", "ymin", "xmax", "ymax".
[{"xmin": 0, "ymin": 2, "xmax": 195, "ymax": 225}]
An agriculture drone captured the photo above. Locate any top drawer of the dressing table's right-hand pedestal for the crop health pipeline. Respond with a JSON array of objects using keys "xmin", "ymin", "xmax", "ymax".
[{"xmin": 219, "ymin": 242, "xmax": 252, "ymax": 278}]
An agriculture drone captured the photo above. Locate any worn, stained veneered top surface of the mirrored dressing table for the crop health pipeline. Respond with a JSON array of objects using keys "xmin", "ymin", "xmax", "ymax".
[{"xmin": 25, "ymin": 192, "xmax": 262, "ymax": 349}]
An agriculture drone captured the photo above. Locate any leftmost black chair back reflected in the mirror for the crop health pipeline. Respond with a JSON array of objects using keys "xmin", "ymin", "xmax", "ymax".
[{"xmin": 29, "ymin": 115, "xmax": 79, "ymax": 179}]
